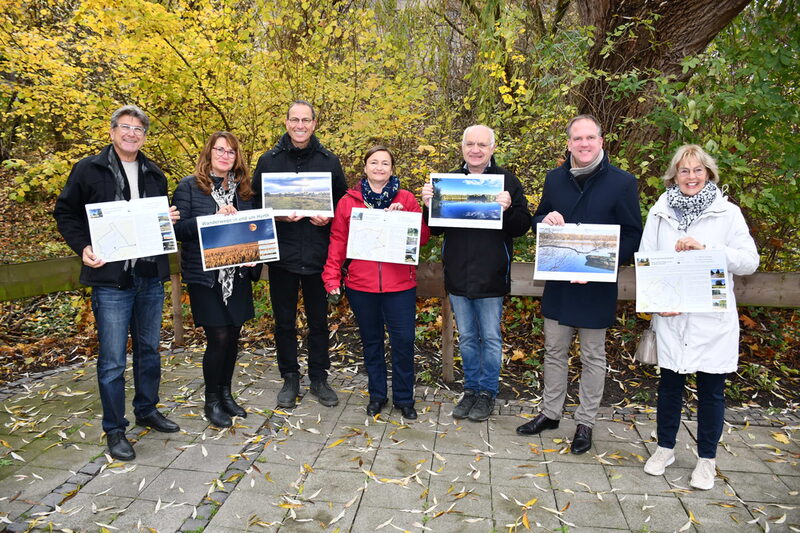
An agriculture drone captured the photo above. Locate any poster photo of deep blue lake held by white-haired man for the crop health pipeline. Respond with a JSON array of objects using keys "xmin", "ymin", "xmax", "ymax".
[{"xmin": 428, "ymin": 174, "xmax": 504, "ymax": 229}]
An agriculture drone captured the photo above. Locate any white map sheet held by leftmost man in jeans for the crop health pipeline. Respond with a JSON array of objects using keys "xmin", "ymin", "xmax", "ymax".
[{"xmin": 86, "ymin": 196, "xmax": 178, "ymax": 262}]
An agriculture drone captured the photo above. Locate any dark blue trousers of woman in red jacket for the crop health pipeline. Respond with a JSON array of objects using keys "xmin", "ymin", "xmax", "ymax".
[{"xmin": 346, "ymin": 288, "xmax": 417, "ymax": 407}]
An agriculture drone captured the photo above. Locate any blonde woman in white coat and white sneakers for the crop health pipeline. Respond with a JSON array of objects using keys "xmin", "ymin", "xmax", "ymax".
[{"xmin": 639, "ymin": 144, "xmax": 759, "ymax": 490}]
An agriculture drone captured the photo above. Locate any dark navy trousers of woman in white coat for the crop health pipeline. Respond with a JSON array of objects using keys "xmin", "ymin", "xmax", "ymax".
[{"xmin": 656, "ymin": 368, "xmax": 725, "ymax": 459}]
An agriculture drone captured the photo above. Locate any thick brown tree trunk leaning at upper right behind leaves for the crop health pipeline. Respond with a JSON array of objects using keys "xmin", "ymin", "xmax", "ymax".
[{"xmin": 575, "ymin": 0, "xmax": 749, "ymax": 152}]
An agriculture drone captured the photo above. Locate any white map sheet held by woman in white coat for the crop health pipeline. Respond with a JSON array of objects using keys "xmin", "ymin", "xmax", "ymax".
[{"xmin": 634, "ymin": 250, "xmax": 731, "ymax": 313}]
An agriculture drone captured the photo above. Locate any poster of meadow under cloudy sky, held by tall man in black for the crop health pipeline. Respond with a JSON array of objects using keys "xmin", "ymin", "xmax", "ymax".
[{"xmin": 261, "ymin": 172, "xmax": 333, "ymax": 217}]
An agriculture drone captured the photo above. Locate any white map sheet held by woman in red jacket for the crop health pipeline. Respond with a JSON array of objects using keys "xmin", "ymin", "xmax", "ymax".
[{"xmin": 347, "ymin": 207, "xmax": 422, "ymax": 265}]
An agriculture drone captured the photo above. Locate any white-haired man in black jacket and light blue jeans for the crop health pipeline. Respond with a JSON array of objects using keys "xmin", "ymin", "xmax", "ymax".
[{"xmin": 422, "ymin": 125, "xmax": 531, "ymax": 422}]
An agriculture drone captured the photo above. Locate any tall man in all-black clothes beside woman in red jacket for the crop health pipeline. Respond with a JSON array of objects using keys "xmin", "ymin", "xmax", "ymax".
[{"xmin": 253, "ymin": 100, "xmax": 347, "ymax": 408}]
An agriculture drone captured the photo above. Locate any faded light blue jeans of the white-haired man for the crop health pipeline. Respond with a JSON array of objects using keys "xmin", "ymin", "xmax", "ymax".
[{"xmin": 450, "ymin": 294, "xmax": 503, "ymax": 397}]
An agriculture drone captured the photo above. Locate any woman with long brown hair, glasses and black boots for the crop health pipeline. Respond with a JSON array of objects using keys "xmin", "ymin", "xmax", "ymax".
[{"xmin": 172, "ymin": 131, "xmax": 260, "ymax": 427}]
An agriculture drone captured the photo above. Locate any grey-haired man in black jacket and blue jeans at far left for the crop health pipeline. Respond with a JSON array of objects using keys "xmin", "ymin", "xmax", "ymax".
[{"xmin": 53, "ymin": 105, "xmax": 180, "ymax": 461}]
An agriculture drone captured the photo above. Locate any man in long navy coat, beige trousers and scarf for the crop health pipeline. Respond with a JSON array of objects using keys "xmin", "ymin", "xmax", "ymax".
[{"xmin": 517, "ymin": 115, "xmax": 642, "ymax": 454}]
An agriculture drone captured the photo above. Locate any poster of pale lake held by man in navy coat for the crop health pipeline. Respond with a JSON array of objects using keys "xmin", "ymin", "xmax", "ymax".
[{"xmin": 533, "ymin": 224, "xmax": 619, "ymax": 283}]
